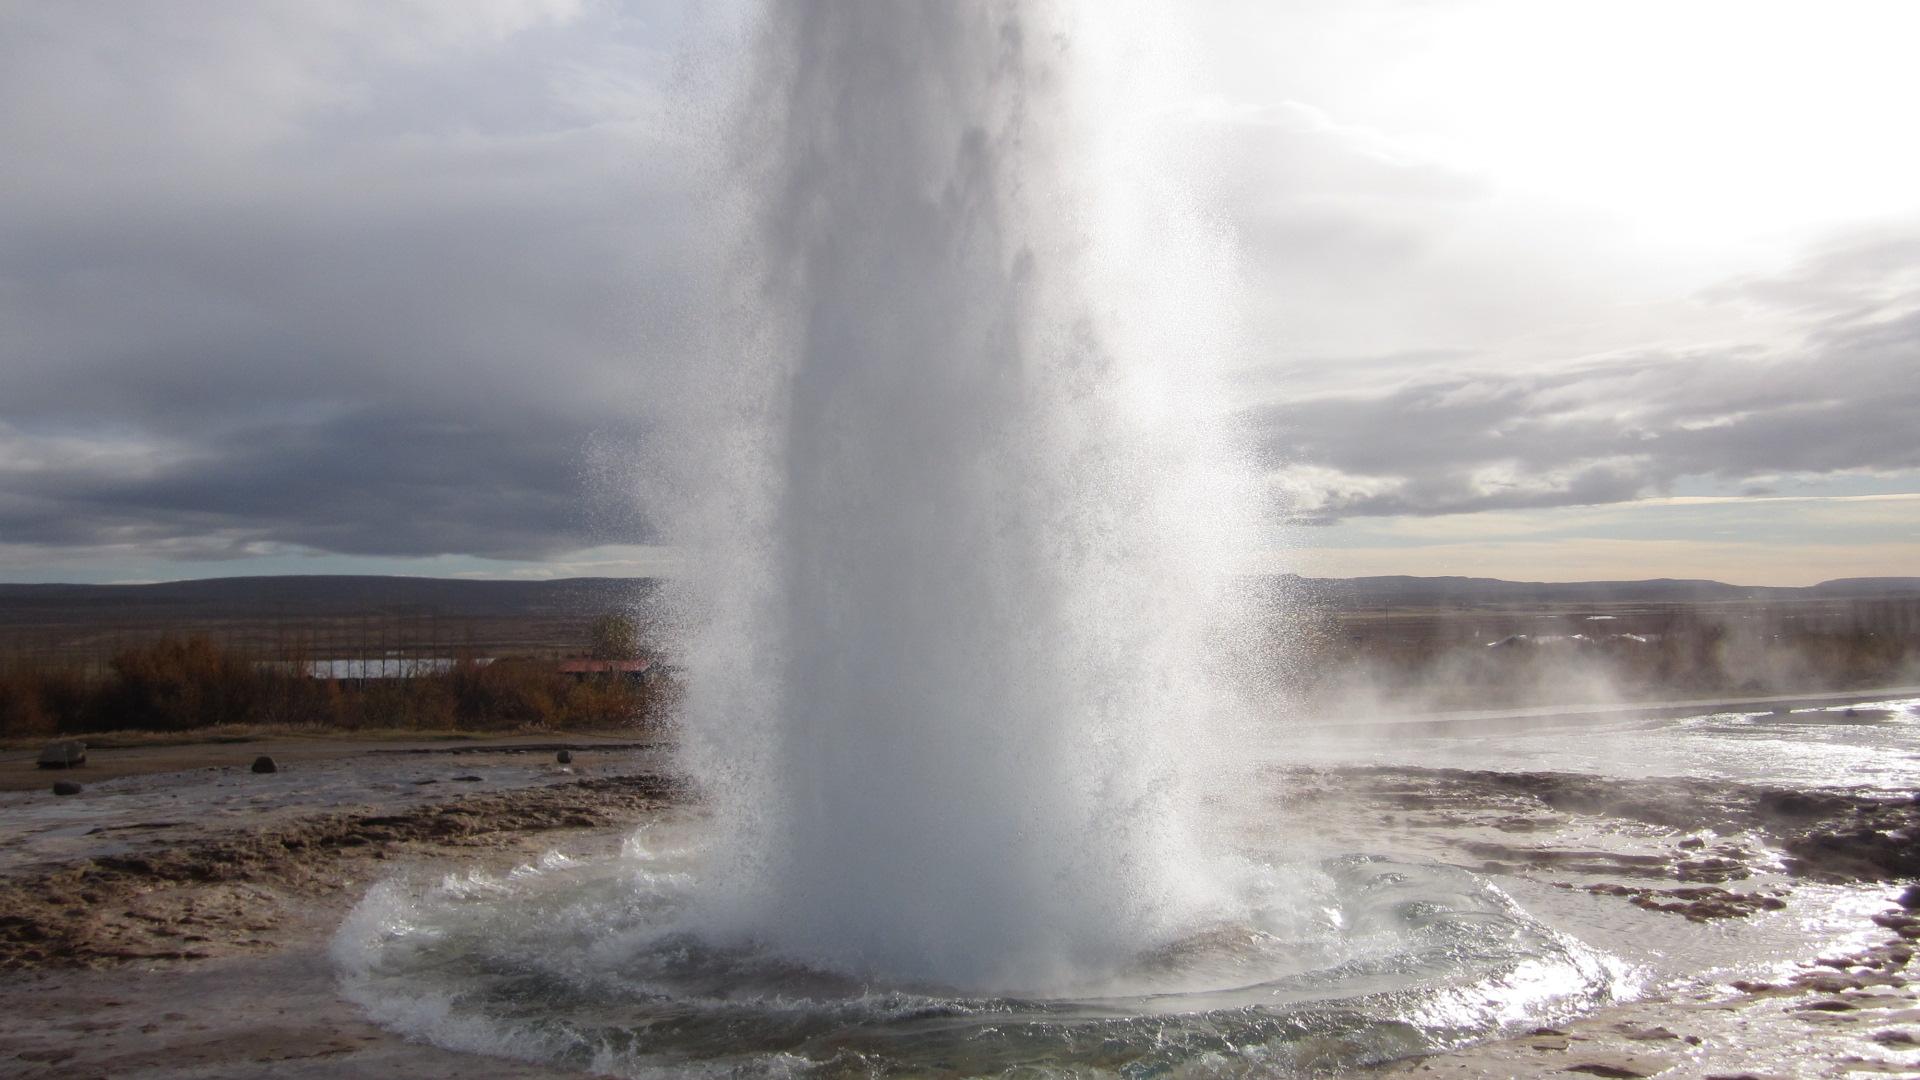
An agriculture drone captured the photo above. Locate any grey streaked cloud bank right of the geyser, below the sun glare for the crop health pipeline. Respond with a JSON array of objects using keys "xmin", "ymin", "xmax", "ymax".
[{"xmin": 1252, "ymin": 236, "xmax": 1920, "ymax": 521}]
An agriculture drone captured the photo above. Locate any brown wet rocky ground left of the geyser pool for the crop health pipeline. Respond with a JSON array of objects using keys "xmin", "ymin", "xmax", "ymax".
[{"xmin": 0, "ymin": 740, "xmax": 672, "ymax": 1078}]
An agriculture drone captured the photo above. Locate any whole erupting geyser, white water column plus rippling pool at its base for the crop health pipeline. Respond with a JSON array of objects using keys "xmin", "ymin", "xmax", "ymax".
[{"xmin": 336, "ymin": 2, "xmax": 1617, "ymax": 1074}]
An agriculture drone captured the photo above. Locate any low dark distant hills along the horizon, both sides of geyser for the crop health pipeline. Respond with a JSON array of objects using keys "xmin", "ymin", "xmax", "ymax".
[{"xmin": 0, "ymin": 575, "xmax": 1920, "ymax": 626}]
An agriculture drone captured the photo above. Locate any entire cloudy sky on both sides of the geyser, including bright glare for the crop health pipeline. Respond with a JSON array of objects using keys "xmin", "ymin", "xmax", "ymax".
[{"xmin": 0, "ymin": 0, "xmax": 1920, "ymax": 584}]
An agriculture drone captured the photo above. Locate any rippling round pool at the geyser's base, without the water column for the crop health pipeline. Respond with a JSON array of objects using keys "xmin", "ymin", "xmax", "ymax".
[{"xmin": 334, "ymin": 822, "xmax": 1622, "ymax": 1076}]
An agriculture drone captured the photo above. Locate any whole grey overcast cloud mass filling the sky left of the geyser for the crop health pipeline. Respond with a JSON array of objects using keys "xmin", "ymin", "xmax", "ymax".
[{"xmin": 0, "ymin": 0, "xmax": 714, "ymax": 557}]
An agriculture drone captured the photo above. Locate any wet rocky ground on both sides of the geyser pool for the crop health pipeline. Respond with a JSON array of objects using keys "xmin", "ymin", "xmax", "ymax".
[{"xmin": 0, "ymin": 734, "xmax": 1920, "ymax": 1078}]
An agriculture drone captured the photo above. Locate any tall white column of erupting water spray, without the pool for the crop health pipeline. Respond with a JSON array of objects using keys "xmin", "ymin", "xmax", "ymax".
[{"xmin": 660, "ymin": 2, "xmax": 1252, "ymax": 990}]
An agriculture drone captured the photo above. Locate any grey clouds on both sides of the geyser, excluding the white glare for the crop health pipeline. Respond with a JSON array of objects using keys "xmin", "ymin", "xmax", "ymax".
[{"xmin": 0, "ymin": 0, "xmax": 1920, "ymax": 580}]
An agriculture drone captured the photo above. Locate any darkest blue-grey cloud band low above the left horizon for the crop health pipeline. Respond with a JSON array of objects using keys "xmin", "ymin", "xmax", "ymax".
[{"xmin": 0, "ymin": 409, "xmax": 629, "ymax": 557}]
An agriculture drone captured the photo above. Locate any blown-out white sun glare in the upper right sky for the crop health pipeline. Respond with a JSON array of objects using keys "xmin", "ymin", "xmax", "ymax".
[{"xmin": 1382, "ymin": 0, "xmax": 1920, "ymax": 246}]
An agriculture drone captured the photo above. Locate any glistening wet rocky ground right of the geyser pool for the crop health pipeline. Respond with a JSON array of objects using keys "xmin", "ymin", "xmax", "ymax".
[{"xmin": 1281, "ymin": 769, "xmax": 1920, "ymax": 1080}]
